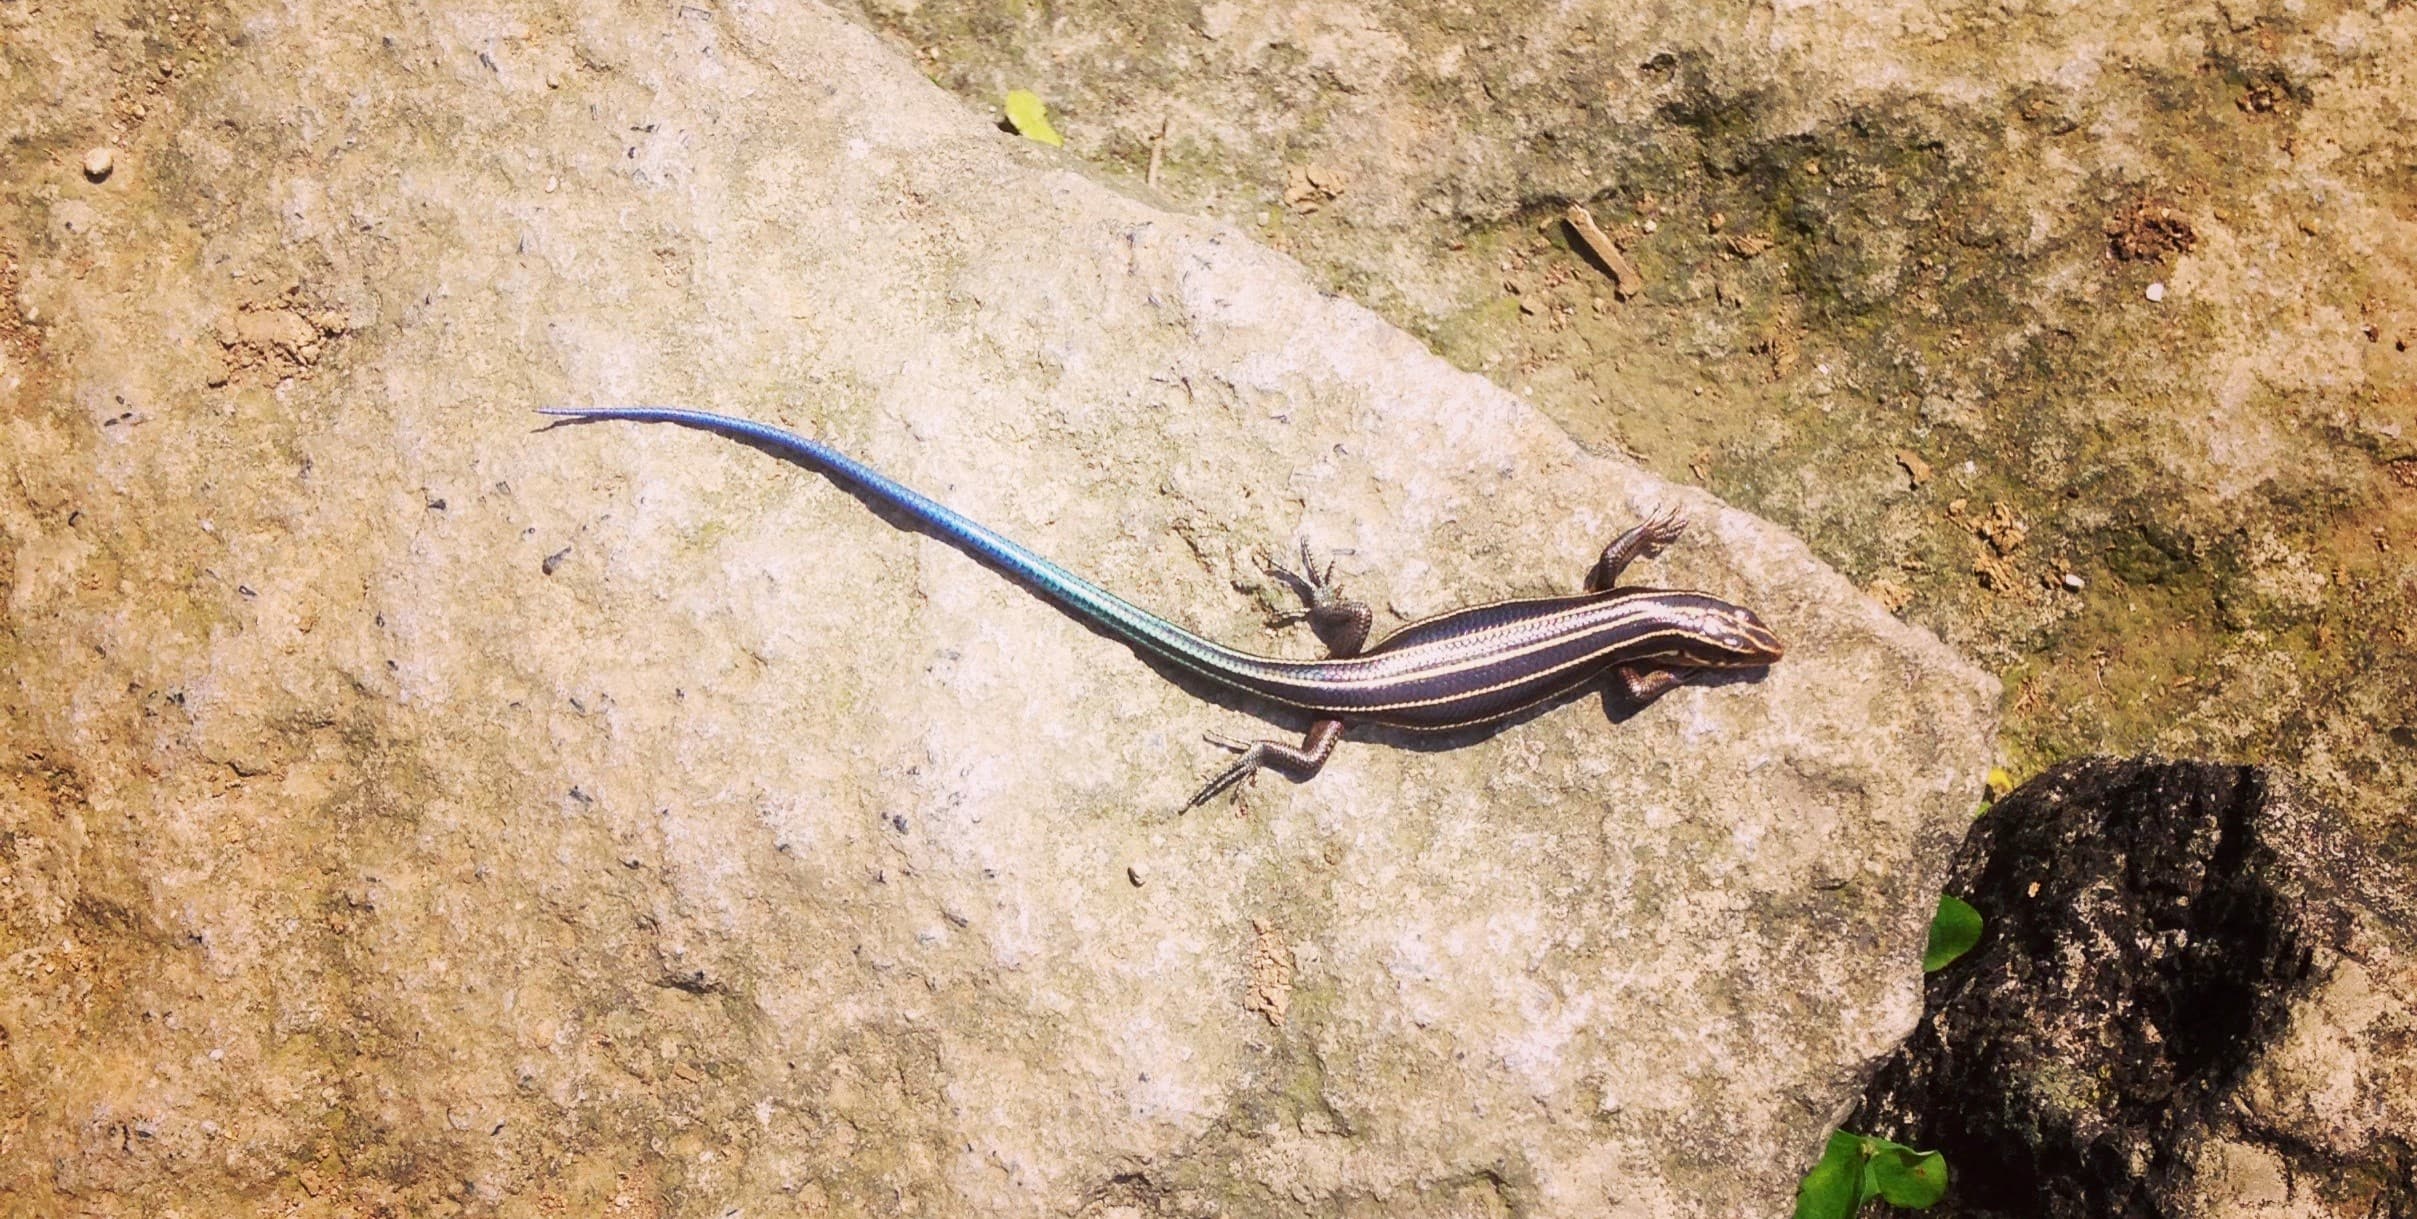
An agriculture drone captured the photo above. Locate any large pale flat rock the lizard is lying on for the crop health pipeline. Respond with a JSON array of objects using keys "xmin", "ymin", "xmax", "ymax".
[{"xmin": 0, "ymin": 5, "xmax": 1996, "ymax": 1217}]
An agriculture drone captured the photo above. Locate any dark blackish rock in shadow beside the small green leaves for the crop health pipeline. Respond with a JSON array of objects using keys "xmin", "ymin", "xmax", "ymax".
[{"xmin": 1851, "ymin": 759, "xmax": 2417, "ymax": 1219}]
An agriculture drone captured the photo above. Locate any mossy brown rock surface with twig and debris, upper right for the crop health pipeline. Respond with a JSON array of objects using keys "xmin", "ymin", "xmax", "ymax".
[{"xmin": 853, "ymin": 0, "xmax": 2417, "ymax": 923}]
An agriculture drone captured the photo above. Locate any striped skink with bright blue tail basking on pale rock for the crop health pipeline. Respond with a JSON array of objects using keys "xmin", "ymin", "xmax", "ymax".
[{"xmin": 539, "ymin": 406, "xmax": 1784, "ymax": 808}]
